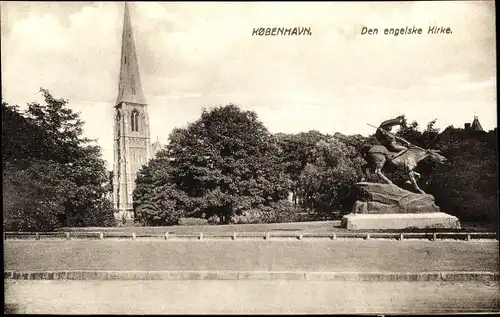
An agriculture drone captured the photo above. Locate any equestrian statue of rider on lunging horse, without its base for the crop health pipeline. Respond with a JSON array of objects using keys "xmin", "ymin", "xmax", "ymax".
[{"xmin": 361, "ymin": 116, "xmax": 446, "ymax": 194}]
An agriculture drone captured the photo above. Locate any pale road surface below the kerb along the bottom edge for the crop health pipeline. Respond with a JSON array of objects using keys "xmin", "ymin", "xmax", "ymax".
[{"xmin": 5, "ymin": 281, "xmax": 499, "ymax": 314}]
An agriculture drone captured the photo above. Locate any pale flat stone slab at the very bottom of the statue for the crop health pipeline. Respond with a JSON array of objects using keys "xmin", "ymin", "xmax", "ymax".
[{"xmin": 341, "ymin": 212, "xmax": 460, "ymax": 230}]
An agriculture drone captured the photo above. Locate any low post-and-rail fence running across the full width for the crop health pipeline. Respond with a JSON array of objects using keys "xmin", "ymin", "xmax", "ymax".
[{"xmin": 4, "ymin": 231, "xmax": 498, "ymax": 241}]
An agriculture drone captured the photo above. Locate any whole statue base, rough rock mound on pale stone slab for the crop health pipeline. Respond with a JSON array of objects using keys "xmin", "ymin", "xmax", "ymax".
[{"xmin": 341, "ymin": 182, "xmax": 460, "ymax": 230}]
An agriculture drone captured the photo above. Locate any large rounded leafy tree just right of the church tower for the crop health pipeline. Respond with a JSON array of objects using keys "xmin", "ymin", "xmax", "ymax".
[{"xmin": 135, "ymin": 105, "xmax": 288, "ymax": 223}]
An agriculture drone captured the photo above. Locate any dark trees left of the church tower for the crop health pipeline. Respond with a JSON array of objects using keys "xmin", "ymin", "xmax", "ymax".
[{"xmin": 2, "ymin": 89, "xmax": 115, "ymax": 231}]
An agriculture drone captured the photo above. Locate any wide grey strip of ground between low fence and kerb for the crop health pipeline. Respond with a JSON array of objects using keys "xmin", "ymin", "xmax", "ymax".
[{"xmin": 4, "ymin": 239, "xmax": 499, "ymax": 273}]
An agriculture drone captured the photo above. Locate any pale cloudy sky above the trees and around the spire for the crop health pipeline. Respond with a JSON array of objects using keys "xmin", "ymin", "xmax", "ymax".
[{"xmin": 1, "ymin": 1, "xmax": 497, "ymax": 168}]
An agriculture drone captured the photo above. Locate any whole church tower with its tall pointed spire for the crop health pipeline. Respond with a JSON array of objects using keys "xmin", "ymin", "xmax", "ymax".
[{"xmin": 113, "ymin": 3, "xmax": 151, "ymax": 219}]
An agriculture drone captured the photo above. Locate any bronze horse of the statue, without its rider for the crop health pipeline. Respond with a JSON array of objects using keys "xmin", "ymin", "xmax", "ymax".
[{"xmin": 361, "ymin": 145, "xmax": 446, "ymax": 194}]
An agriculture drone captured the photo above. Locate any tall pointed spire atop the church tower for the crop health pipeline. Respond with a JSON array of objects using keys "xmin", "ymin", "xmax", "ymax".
[{"xmin": 115, "ymin": 2, "xmax": 146, "ymax": 105}]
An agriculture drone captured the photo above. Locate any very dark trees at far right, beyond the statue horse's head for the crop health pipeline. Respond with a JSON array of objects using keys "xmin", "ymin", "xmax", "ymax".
[{"xmin": 427, "ymin": 127, "xmax": 498, "ymax": 224}]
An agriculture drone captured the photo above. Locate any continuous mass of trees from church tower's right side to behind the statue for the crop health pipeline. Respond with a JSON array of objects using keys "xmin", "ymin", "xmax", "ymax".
[{"xmin": 134, "ymin": 105, "xmax": 498, "ymax": 225}]
